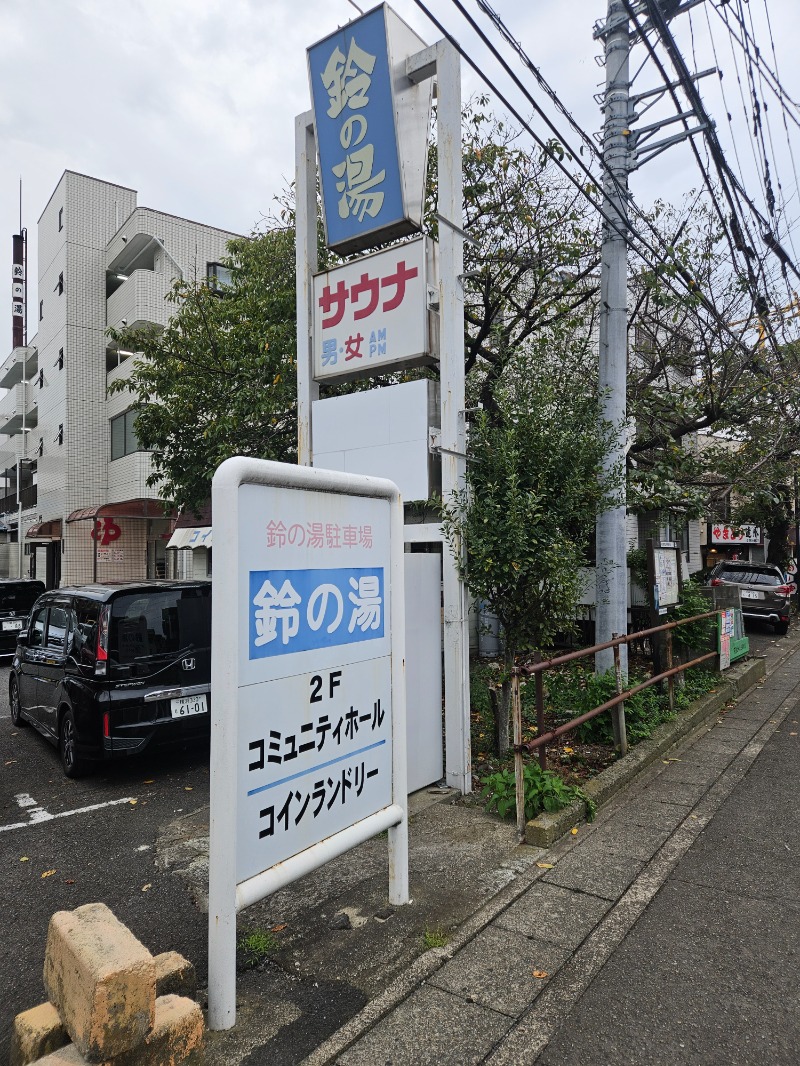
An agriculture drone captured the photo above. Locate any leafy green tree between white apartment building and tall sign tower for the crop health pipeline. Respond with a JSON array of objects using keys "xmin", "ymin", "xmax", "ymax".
[{"xmin": 110, "ymin": 228, "xmax": 297, "ymax": 512}]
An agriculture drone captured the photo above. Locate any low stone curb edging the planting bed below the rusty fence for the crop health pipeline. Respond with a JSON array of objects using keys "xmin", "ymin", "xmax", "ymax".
[{"xmin": 525, "ymin": 659, "xmax": 767, "ymax": 847}]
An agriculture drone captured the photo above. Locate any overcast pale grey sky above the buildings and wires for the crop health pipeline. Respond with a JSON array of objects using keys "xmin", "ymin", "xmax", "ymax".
[{"xmin": 0, "ymin": 0, "xmax": 800, "ymax": 345}]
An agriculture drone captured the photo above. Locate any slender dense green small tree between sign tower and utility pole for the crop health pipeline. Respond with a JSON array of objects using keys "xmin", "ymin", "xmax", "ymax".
[{"xmin": 444, "ymin": 345, "xmax": 622, "ymax": 752}]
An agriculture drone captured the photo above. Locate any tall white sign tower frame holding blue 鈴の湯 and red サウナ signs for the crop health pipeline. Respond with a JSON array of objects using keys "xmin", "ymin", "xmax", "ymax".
[{"xmin": 295, "ymin": 4, "xmax": 471, "ymax": 792}]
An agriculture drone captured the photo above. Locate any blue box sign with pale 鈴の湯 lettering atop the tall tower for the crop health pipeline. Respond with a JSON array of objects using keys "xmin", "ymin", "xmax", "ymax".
[{"xmin": 308, "ymin": 4, "xmax": 431, "ymax": 254}]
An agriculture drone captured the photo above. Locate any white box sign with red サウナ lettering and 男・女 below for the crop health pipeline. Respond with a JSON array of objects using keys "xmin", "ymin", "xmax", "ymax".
[{"xmin": 313, "ymin": 238, "xmax": 435, "ymax": 381}]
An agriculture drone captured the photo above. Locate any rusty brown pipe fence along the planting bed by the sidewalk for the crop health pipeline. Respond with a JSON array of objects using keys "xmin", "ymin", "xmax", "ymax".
[{"xmin": 511, "ymin": 611, "xmax": 721, "ymax": 843}]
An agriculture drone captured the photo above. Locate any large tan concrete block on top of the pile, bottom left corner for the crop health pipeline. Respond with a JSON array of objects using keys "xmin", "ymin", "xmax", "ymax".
[{"xmin": 44, "ymin": 903, "xmax": 156, "ymax": 1063}]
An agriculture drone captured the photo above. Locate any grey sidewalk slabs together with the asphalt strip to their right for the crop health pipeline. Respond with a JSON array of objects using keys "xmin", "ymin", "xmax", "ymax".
[{"xmin": 302, "ymin": 641, "xmax": 800, "ymax": 1066}]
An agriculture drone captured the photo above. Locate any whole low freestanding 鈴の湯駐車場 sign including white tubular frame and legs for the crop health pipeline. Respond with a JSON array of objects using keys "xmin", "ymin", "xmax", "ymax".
[{"xmin": 209, "ymin": 458, "xmax": 407, "ymax": 1029}]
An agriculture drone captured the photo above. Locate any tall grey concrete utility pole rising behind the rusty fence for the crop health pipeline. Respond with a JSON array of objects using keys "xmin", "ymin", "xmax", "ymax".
[{"xmin": 595, "ymin": 0, "xmax": 630, "ymax": 676}]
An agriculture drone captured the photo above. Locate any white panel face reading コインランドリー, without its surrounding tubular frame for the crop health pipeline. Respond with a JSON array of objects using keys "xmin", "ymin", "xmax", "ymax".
[{"xmin": 237, "ymin": 485, "xmax": 391, "ymax": 883}]
